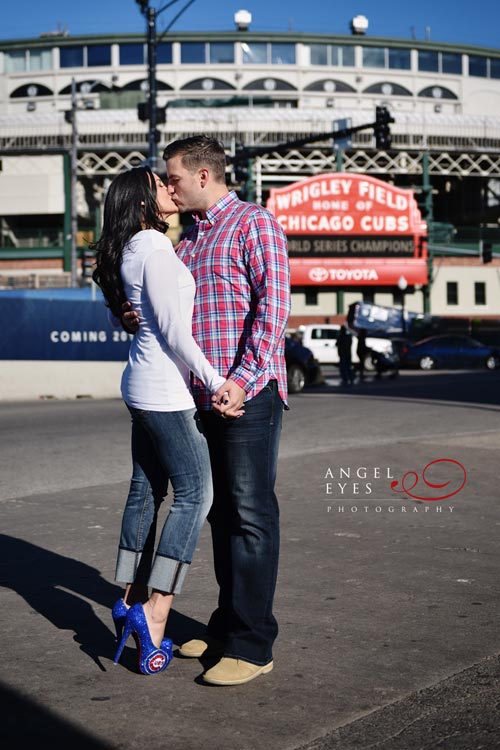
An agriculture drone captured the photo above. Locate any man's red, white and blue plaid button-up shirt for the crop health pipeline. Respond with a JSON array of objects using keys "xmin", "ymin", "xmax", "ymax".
[{"xmin": 177, "ymin": 192, "xmax": 290, "ymax": 409}]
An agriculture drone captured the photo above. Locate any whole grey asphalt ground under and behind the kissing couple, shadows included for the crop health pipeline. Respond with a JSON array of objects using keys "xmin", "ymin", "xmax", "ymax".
[{"xmin": 0, "ymin": 371, "xmax": 500, "ymax": 750}]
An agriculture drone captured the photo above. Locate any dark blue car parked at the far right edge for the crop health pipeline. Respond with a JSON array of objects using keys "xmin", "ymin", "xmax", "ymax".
[{"xmin": 401, "ymin": 334, "xmax": 500, "ymax": 370}]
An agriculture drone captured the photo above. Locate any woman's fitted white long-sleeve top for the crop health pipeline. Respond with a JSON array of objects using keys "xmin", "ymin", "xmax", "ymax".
[{"xmin": 121, "ymin": 229, "xmax": 225, "ymax": 411}]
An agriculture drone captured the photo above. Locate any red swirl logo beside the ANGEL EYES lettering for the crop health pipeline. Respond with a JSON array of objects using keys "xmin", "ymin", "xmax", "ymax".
[{"xmin": 391, "ymin": 458, "xmax": 467, "ymax": 502}]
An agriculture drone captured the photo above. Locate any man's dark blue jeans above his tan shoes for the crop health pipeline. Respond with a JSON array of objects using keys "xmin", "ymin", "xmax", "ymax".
[{"xmin": 200, "ymin": 380, "xmax": 283, "ymax": 664}]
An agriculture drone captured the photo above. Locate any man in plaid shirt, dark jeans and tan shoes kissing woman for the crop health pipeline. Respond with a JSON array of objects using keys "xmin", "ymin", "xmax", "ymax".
[{"xmin": 126, "ymin": 136, "xmax": 290, "ymax": 685}]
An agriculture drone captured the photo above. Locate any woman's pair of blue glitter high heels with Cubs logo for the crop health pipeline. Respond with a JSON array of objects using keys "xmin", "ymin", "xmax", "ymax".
[{"xmin": 114, "ymin": 604, "xmax": 173, "ymax": 674}]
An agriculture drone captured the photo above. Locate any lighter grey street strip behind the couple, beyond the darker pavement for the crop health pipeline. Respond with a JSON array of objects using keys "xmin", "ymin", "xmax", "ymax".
[{"xmin": 0, "ymin": 367, "xmax": 500, "ymax": 500}]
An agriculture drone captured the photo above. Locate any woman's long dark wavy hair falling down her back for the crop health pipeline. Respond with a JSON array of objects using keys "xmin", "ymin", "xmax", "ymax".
[{"xmin": 90, "ymin": 166, "xmax": 168, "ymax": 318}]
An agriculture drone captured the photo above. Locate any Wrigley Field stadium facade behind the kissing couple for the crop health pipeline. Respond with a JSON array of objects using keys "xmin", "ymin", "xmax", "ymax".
[{"xmin": 0, "ymin": 14, "xmax": 500, "ymax": 324}]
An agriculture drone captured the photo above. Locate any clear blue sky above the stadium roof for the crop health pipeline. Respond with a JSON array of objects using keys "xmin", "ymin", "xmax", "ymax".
[{"xmin": 0, "ymin": 0, "xmax": 500, "ymax": 49}]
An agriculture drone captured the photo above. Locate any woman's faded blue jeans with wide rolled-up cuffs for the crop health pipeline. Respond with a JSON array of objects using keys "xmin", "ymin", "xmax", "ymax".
[{"xmin": 115, "ymin": 407, "xmax": 213, "ymax": 594}]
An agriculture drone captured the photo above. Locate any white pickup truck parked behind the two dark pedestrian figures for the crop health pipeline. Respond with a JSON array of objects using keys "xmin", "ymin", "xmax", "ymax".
[{"xmin": 298, "ymin": 323, "xmax": 393, "ymax": 370}]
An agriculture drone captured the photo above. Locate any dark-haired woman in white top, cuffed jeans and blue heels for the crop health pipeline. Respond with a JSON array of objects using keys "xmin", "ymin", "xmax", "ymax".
[{"xmin": 93, "ymin": 167, "xmax": 230, "ymax": 674}]
